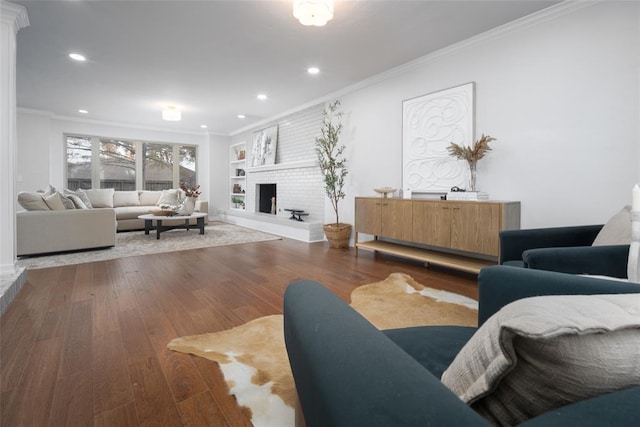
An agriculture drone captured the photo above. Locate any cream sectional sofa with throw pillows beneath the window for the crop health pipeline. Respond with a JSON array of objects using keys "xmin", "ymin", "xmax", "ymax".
[{"xmin": 16, "ymin": 187, "xmax": 208, "ymax": 256}]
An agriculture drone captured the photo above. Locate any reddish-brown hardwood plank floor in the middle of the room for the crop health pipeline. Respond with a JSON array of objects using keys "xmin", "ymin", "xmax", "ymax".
[{"xmin": 0, "ymin": 239, "xmax": 477, "ymax": 427}]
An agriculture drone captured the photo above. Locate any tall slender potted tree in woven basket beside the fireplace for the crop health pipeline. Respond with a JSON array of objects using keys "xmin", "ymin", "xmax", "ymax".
[{"xmin": 315, "ymin": 100, "xmax": 351, "ymax": 248}]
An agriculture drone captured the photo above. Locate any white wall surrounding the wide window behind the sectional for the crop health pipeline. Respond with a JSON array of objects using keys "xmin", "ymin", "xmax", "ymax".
[{"xmin": 16, "ymin": 109, "xmax": 214, "ymax": 200}]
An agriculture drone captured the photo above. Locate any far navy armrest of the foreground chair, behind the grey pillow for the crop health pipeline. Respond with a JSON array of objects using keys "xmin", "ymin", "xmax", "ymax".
[{"xmin": 478, "ymin": 265, "xmax": 640, "ymax": 325}]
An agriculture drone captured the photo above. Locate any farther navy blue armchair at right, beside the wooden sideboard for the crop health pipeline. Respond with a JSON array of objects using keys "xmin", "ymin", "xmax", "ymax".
[{"xmin": 498, "ymin": 224, "xmax": 629, "ymax": 278}]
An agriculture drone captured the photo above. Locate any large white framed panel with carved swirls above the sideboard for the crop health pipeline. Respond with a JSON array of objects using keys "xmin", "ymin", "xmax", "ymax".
[{"xmin": 402, "ymin": 82, "xmax": 475, "ymax": 193}]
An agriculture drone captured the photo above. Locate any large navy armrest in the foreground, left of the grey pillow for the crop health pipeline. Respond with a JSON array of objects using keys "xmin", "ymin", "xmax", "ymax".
[{"xmin": 284, "ymin": 281, "xmax": 488, "ymax": 427}]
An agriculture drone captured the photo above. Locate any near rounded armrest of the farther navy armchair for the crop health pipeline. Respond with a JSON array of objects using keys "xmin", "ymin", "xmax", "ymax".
[{"xmin": 522, "ymin": 245, "xmax": 629, "ymax": 278}]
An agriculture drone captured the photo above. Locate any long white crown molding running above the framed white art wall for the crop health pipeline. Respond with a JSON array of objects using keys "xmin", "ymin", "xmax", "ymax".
[{"xmin": 229, "ymin": 0, "xmax": 606, "ymax": 136}]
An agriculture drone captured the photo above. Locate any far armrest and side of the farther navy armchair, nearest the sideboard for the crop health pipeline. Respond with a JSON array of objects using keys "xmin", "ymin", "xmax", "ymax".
[{"xmin": 498, "ymin": 224, "xmax": 603, "ymax": 264}]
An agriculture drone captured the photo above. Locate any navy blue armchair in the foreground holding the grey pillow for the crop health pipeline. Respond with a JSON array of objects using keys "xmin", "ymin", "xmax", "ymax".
[{"xmin": 284, "ymin": 266, "xmax": 640, "ymax": 427}]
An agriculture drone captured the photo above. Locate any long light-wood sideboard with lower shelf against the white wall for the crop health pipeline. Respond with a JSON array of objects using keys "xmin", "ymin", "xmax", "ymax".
[{"xmin": 355, "ymin": 197, "xmax": 520, "ymax": 273}]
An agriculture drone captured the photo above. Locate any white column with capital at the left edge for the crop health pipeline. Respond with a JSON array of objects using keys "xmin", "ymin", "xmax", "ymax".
[{"xmin": 0, "ymin": 0, "xmax": 29, "ymax": 277}]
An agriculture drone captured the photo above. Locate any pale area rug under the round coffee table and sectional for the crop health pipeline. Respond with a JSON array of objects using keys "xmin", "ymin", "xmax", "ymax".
[{"xmin": 18, "ymin": 221, "xmax": 281, "ymax": 269}]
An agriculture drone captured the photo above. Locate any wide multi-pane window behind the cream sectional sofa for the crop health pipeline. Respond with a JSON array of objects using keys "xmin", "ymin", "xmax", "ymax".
[{"xmin": 65, "ymin": 135, "xmax": 197, "ymax": 190}]
